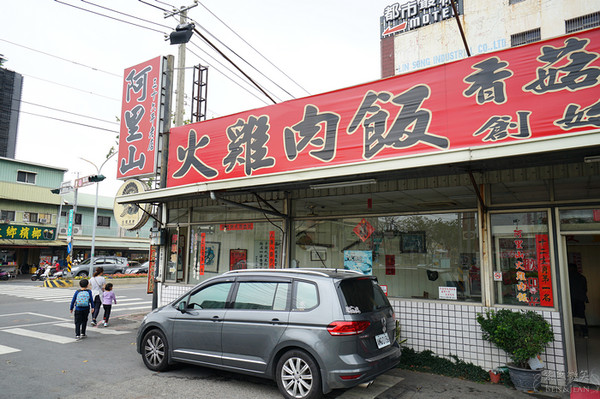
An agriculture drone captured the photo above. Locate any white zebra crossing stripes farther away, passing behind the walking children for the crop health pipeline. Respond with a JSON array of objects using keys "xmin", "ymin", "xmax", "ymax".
[{"xmin": 0, "ymin": 285, "xmax": 152, "ymax": 314}]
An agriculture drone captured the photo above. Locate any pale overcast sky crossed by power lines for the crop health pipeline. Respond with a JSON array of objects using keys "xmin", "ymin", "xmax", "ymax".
[{"xmin": 0, "ymin": 0, "xmax": 395, "ymax": 196}]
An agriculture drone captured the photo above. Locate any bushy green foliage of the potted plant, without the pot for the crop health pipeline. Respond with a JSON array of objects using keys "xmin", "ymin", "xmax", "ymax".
[{"xmin": 477, "ymin": 309, "xmax": 554, "ymax": 368}]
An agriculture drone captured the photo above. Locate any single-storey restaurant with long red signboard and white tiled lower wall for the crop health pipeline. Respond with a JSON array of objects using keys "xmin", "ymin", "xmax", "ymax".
[{"xmin": 117, "ymin": 13, "xmax": 600, "ymax": 394}]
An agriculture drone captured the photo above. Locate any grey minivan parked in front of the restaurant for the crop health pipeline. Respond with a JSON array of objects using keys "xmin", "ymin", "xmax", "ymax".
[{"xmin": 137, "ymin": 269, "xmax": 400, "ymax": 398}]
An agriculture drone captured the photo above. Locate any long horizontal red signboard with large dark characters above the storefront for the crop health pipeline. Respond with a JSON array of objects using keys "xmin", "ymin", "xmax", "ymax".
[{"xmin": 167, "ymin": 29, "xmax": 600, "ymax": 187}]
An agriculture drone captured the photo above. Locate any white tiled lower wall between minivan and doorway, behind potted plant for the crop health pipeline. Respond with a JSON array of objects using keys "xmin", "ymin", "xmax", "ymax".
[{"xmin": 391, "ymin": 300, "xmax": 566, "ymax": 387}]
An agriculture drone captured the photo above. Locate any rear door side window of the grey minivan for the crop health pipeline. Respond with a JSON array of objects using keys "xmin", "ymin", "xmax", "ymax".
[{"xmin": 233, "ymin": 281, "xmax": 290, "ymax": 310}]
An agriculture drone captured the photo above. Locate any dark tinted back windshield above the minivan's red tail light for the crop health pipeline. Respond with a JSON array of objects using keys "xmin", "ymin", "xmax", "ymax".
[{"xmin": 340, "ymin": 278, "xmax": 390, "ymax": 314}]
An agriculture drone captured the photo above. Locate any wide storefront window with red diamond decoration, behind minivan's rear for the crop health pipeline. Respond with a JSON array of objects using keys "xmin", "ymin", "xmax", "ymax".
[{"xmin": 292, "ymin": 212, "xmax": 481, "ymax": 302}]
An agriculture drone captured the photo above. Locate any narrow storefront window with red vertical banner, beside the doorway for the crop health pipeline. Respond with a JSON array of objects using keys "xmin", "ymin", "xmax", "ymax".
[{"xmin": 491, "ymin": 211, "xmax": 554, "ymax": 307}]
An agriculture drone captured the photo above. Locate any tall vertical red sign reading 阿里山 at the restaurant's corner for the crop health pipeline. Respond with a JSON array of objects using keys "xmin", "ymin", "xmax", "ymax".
[{"xmin": 117, "ymin": 57, "xmax": 164, "ymax": 179}]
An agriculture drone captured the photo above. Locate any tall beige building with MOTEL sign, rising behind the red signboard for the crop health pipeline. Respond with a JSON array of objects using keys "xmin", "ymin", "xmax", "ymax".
[{"xmin": 380, "ymin": 0, "xmax": 600, "ymax": 78}]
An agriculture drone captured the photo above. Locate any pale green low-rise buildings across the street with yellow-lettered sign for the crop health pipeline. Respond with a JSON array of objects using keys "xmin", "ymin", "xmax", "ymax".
[{"xmin": 0, "ymin": 158, "xmax": 150, "ymax": 272}]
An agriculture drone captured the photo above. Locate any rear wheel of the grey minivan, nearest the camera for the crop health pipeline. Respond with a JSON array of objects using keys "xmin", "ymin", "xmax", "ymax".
[{"xmin": 277, "ymin": 350, "xmax": 323, "ymax": 399}]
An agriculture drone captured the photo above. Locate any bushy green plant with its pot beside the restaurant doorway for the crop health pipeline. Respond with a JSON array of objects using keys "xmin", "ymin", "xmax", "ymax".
[{"xmin": 477, "ymin": 309, "xmax": 554, "ymax": 391}]
